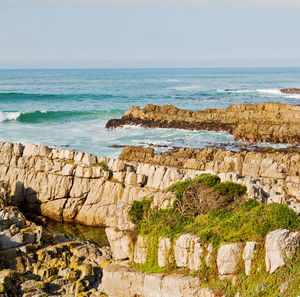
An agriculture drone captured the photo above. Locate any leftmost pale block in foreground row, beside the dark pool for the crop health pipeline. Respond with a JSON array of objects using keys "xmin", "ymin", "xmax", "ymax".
[{"xmin": 105, "ymin": 228, "xmax": 132, "ymax": 260}]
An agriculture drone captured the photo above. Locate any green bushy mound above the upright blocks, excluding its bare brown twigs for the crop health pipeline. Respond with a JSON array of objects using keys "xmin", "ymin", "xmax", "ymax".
[{"xmin": 129, "ymin": 174, "xmax": 300, "ymax": 245}]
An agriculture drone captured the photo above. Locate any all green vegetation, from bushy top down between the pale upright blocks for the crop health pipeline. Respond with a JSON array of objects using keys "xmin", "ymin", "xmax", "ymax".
[{"xmin": 129, "ymin": 174, "xmax": 300, "ymax": 297}]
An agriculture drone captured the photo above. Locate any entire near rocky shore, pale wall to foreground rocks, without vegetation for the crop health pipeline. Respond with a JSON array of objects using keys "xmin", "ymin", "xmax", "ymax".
[{"xmin": 0, "ymin": 138, "xmax": 300, "ymax": 297}]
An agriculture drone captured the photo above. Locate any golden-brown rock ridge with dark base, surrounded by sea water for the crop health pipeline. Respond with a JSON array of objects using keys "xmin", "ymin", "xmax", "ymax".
[{"xmin": 106, "ymin": 103, "xmax": 300, "ymax": 144}]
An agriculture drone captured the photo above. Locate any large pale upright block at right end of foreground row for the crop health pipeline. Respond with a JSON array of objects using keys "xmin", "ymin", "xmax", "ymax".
[{"xmin": 265, "ymin": 229, "xmax": 300, "ymax": 273}]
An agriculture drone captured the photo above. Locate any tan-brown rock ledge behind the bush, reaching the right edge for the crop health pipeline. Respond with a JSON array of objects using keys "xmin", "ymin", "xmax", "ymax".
[{"xmin": 119, "ymin": 146, "xmax": 300, "ymax": 207}]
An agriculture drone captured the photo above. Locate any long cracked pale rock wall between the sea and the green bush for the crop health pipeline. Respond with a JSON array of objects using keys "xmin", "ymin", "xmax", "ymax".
[{"xmin": 0, "ymin": 142, "xmax": 300, "ymax": 230}]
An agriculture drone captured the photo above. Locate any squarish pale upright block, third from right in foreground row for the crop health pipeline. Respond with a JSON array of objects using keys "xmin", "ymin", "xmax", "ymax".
[{"xmin": 217, "ymin": 243, "xmax": 243, "ymax": 276}]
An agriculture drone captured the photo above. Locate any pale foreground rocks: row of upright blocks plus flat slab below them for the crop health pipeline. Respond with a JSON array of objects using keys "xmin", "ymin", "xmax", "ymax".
[{"xmin": 102, "ymin": 229, "xmax": 300, "ymax": 297}]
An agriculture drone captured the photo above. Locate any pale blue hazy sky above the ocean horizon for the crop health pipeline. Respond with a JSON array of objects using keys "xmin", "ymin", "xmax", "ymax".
[{"xmin": 0, "ymin": 0, "xmax": 300, "ymax": 69}]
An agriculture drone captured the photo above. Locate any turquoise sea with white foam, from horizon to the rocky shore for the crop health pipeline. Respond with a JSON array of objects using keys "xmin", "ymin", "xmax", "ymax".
[{"xmin": 0, "ymin": 68, "xmax": 300, "ymax": 157}]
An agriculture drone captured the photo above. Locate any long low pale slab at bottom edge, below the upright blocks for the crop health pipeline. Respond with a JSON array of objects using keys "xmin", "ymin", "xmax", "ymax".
[{"xmin": 102, "ymin": 264, "xmax": 215, "ymax": 297}]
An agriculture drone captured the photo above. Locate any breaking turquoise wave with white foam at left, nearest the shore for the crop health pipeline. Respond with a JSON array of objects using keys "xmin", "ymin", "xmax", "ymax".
[{"xmin": 0, "ymin": 109, "xmax": 124, "ymax": 123}]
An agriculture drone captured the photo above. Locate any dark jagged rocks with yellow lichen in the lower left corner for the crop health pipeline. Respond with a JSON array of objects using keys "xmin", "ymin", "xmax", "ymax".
[{"xmin": 0, "ymin": 202, "xmax": 111, "ymax": 297}]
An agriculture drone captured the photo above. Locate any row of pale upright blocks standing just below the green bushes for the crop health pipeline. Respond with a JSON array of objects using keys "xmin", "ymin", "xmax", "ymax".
[{"xmin": 107, "ymin": 229, "xmax": 300, "ymax": 278}]
